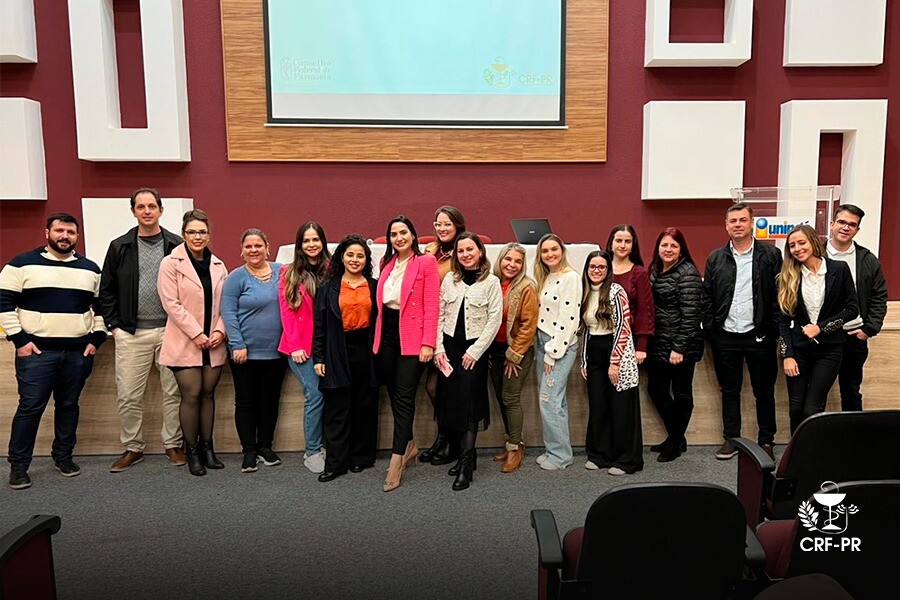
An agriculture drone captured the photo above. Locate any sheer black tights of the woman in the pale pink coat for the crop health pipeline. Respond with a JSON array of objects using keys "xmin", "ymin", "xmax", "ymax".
[{"xmin": 173, "ymin": 366, "xmax": 222, "ymax": 446}]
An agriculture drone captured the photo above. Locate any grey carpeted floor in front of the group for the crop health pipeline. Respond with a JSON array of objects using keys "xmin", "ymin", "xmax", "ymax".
[{"xmin": 0, "ymin": 446, "xmax": 737, "ymax": 600}]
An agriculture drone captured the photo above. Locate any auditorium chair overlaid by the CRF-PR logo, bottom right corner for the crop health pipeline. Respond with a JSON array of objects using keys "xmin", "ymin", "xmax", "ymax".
[{"xmin": 757, "ymin": 480, "xmax": 900, "ymax": 600}]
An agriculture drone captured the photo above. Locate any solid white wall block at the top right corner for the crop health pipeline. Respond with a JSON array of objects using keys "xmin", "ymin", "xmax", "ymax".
[{"xmin": 783, "ymin": 0, "xmax": 887, "ymax": 67}]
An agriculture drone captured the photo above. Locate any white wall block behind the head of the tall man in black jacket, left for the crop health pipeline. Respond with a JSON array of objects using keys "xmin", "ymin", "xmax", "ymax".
[{"xmin": 81, "ymin": 197, "xmax": 194, "ymax": 267}]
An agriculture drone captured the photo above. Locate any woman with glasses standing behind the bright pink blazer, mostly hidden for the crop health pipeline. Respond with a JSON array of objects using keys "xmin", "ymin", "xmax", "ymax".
[{"xmin": 419, "ymin": 205, "xmax": 466, "ymax": 465}]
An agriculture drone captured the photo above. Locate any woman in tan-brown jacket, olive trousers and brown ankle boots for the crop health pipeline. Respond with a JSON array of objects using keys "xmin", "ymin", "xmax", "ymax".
[{"xmin": 488, "ymin": 243, "xmax": 538, "ymax": 473}]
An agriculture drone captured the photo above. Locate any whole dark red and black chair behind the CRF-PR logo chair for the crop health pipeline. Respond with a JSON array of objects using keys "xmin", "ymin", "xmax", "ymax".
[{"xmin": 731, "ymin": 410, "xmax": 900, "ymax": 526}]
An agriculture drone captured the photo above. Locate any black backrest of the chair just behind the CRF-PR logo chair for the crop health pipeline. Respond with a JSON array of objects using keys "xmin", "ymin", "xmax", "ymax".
[{"xmin": 767, "ymin": 410, "xmax": 900, "ymax": 519}]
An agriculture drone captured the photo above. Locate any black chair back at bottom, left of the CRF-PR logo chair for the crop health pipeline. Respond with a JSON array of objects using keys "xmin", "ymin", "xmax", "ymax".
[{"xmin": 577, "ymin": 483, "xmax": 747, "ymax": 599}]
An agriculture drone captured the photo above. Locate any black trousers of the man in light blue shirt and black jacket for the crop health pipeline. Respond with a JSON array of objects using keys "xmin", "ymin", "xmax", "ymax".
[{"xmin": 713, "ymin": 331, "xmax": 778, "ymax": 444}]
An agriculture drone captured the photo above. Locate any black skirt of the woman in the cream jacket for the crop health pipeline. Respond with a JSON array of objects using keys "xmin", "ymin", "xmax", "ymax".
[{"xmin": 436, "ymin": 334, "xmax": 491, "ymax": 432}]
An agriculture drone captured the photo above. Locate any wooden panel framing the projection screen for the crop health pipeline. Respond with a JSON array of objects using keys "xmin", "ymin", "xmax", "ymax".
[{"xmin": 221, "ymin": 0, "xmax": 609, "ymax": 162}]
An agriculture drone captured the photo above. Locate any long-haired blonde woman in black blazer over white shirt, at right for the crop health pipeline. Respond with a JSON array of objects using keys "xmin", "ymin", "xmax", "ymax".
[{"xmin": 778, "ymin": 225, "xmax": 859, "ymax": 435}]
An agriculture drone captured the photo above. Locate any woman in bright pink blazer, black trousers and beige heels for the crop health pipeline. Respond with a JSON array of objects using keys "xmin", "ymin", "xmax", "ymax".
[{"xmin": 373, "ymin": 215, "xmax": 440, "ymax": 492}]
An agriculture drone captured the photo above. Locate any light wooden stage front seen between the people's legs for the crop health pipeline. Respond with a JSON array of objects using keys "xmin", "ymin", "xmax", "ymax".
[{"xmin": 0, "ymin": 330, "xmax": 900, "ymax": 455}]
